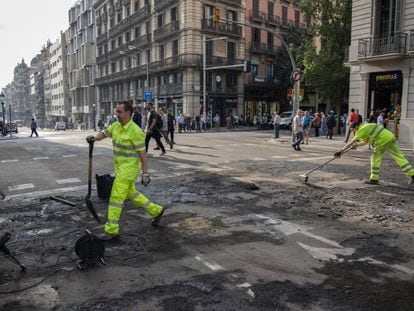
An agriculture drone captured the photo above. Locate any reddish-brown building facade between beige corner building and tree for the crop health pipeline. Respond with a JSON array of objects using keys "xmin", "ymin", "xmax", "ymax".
[{"xmin": 244, "ymin": 0, "xmax": 309, "ymax": 122}]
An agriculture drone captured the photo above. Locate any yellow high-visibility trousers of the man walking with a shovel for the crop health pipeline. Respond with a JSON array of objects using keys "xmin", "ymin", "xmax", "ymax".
[{"xmin": 105, "ymin": 178, "xmax": 163, "ymax": 235}]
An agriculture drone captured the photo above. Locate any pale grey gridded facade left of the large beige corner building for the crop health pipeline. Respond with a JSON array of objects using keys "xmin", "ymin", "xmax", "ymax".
[{"xmin": 66, "ymin": 0, "xmax": 97, "ymax": 128}]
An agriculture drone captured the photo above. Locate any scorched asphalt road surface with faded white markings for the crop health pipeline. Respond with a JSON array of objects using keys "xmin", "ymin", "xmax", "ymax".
[{"xmin": 0, "ymin": 130, "xmax": 414, "ymax": 310}]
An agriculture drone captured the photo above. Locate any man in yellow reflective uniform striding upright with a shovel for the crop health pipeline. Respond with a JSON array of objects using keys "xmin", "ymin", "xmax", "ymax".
[{"xmin": 86, "ymin": 101, "xmax": 164, "ymax": 240}]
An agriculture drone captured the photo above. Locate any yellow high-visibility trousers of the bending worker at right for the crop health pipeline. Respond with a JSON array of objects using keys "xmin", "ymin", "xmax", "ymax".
[{"xmin": 370, "ymin": 139, "xmax": 414, "ymax": 180}]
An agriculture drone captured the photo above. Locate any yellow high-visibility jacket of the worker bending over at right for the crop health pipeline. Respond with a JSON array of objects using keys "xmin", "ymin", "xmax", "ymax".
[{"xmin": 354, "ymin": 123, "xmax": 395, "ymax": 146}]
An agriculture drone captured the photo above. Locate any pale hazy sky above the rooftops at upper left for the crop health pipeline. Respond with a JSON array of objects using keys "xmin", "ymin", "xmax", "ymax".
[{"xmin": 0, "ymin": 0, "xmax": 76, "ymax": 89}]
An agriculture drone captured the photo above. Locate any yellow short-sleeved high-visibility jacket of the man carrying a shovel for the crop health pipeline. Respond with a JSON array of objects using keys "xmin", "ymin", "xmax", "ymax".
[{"xmin": 104, "ymin": 120, "xmax": 145, "ymax": 180}]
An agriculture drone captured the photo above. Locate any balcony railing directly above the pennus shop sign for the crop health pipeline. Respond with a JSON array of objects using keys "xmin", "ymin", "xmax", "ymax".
[{"xmin": 358, "ymin": 32, "xmax": 407, "ymax": 58}]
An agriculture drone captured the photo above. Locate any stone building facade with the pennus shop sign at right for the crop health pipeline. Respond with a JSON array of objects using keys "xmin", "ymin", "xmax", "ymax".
[{"xmin": 348, "ymin": 0, "xmax": 414, "ymax": 148}]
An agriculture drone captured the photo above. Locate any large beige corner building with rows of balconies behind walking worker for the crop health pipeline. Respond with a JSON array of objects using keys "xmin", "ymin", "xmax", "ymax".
[{"xmin": 93, "ymin": 0, "xmax": 244, "ymax": 124}]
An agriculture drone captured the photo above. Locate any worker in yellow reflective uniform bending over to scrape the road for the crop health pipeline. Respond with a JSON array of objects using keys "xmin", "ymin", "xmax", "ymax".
[{"xmin": 334, "ymin": 123, "xmax": 414, "ymax": 185}]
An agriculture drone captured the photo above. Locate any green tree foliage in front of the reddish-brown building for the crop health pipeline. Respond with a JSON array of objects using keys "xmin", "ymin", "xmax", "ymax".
[{"xmin": 298, "ymin": 0, "xmax": 352, "ymax": 102}]
